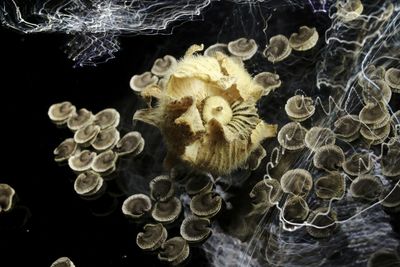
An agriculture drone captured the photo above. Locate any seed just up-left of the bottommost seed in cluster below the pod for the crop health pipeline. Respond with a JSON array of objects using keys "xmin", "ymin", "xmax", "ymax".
[{"xmin": 136, "ymin": 223, "xmax": 168, "ymax": 251}]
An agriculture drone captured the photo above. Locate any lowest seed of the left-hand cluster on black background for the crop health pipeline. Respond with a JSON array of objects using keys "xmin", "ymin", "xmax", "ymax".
[{"xmin": 74, "ymin": 171, "xmax": 104, "ymax": 196}]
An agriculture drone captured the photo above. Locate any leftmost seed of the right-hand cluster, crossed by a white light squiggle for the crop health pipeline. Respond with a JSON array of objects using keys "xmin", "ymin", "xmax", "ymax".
[{"xmin": 249, "ymin": 179, "xmax": 283, "ymax": 206}]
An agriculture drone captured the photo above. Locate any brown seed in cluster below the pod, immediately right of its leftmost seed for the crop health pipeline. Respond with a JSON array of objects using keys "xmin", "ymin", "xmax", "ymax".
[{"xmin": 151, "ymin": 197, "xmax": 182, "ymax": 223}]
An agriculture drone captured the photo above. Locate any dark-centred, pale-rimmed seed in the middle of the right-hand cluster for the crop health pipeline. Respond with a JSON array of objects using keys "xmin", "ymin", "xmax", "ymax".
[{"xmin": 313, "ymin": 145, "xmax": 345, "ymax": 171}]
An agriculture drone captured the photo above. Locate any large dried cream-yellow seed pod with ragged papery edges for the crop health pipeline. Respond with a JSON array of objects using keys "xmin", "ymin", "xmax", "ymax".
[{"xmin": 133, "ymin": 45, "xmax": 277, "ymax": 175}]
